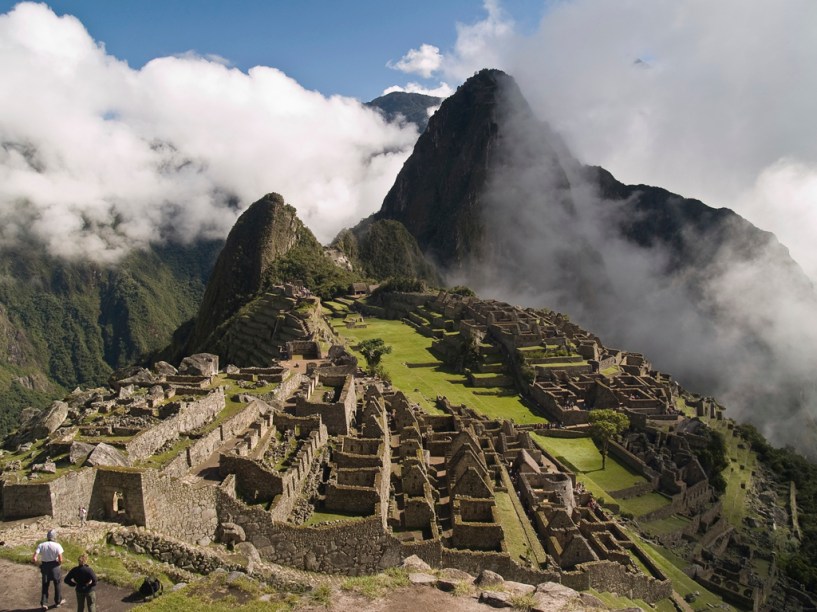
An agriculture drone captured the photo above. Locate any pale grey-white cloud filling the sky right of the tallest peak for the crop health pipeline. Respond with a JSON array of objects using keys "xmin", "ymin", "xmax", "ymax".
[{"xmin": 404, "ymin": 0, "xmax": 817, "ymax": 281}]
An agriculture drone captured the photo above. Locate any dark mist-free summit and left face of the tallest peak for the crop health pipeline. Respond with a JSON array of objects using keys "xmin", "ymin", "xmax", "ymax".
[{"xmin": 375, "ymin": 69, "xmax": 558, "ymax": 269}]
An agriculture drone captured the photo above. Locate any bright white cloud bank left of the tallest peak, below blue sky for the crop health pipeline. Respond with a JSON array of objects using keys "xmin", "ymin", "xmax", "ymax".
[{"xmin": 0, "ymin": 3, "xmax": 417, "ymax": 262}]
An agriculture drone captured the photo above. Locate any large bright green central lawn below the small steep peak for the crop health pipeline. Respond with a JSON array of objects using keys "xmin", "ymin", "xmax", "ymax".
[{"xmin": 337, "ymin": 318, "xmax": 547, "ymax": 423}]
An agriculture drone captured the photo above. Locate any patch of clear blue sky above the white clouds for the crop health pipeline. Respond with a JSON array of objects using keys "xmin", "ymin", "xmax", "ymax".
[{"xmin": 0, "ymin": 0, "xmax": 544, "ymax": 101}]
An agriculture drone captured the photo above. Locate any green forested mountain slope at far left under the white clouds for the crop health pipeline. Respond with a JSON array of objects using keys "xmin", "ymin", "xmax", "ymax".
[{"xmin": 0, "ymin": 241, "xmax": 220, "ymax": 432}]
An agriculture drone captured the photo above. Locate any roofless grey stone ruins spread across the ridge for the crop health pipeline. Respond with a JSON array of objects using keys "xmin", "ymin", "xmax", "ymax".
[{"xmin": 0, "ymin": 294, "xmax": 764, "ymax": 601}]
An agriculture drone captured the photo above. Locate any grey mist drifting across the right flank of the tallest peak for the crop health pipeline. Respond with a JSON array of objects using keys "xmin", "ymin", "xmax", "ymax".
[{"xmin": 460, "ymin": 80, "xmax": 817, "ymax": 458}]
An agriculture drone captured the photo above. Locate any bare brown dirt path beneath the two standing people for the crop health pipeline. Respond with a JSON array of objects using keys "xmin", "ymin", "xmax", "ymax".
[{"xmin": 0, "ymin": 559, "xmax": 135, "ymax": 612}]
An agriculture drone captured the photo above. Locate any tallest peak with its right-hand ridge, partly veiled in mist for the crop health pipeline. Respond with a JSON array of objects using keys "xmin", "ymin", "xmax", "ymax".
[{"xmin": 374, "ymin": 70, "xmax": 817, "ymax": 451}]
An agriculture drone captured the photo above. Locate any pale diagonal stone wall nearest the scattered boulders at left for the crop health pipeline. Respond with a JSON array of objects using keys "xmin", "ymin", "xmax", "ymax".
[{"xmin": 125, "ymin": 387, "xmax": 225, "ymax": 461}]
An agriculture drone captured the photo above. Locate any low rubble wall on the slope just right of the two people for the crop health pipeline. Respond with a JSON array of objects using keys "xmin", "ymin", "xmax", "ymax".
[{"xmin": 108, "ymin": 528, "xmax": 244, "ymax": 574}]
